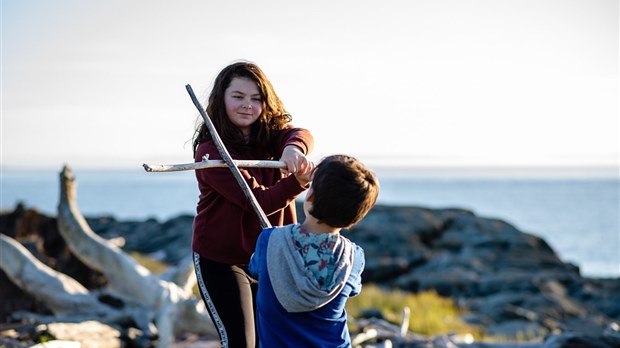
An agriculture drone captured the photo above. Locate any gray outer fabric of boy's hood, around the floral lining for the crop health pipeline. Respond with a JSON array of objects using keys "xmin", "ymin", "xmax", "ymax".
[{"xmin": 267, "ymin": 225, "xmax": 354, "ymax": 312}]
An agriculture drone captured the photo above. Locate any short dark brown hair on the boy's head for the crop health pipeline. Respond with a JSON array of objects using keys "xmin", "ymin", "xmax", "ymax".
[{"xmin": 309, "ymin": 155, "xmax": 379, "ymax": 228}]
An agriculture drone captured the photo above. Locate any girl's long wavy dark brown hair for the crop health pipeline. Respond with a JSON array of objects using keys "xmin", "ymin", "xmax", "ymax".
[{"xmin": 193, "ymin": 61, "xmax": 292, "ymax": 159}]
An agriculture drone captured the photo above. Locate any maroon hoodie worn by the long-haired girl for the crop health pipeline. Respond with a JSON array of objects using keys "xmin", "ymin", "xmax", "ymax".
[{"xmin": 192, "ymin": 125, "xmax": 314, "ymax": 265}]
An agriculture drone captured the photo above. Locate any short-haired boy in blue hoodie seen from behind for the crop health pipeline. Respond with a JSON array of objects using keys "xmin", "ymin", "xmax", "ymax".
[{"xmin": 249, "ymin": 155, "xmax": 379, "ymax": 348}]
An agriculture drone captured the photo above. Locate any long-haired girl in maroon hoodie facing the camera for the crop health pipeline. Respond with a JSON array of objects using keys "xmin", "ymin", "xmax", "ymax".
[{"xmin": 192, "ymin": 62, "xmax": 313, "ymax": 347}]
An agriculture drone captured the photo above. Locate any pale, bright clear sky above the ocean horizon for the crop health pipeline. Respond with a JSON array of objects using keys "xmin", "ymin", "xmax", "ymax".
[{"xmin": 0, "ymin": 0, "xmax": 620, "ymax": 168}]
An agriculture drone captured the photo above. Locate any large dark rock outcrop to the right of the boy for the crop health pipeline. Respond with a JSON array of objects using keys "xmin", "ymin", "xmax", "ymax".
[{"xmin": 345, "ymin": 207, "xmax": 620, "ymax": 336}]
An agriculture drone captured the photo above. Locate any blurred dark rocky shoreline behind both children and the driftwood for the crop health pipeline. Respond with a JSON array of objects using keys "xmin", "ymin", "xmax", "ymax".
[{"xmin": 0, "ymin": 206, "xmax": 620, "ymax": 347}]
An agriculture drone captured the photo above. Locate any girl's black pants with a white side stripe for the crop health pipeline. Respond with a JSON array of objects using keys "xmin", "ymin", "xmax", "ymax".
[{"xmin": 194, "ymin": 253, "xmax": 258, "ymax": 348}]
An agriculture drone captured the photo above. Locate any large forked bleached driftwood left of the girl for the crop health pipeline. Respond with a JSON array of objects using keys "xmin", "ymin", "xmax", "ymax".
[{"xmin": 0, "ymin": 166, "xmax": 217, "ymax": 347}]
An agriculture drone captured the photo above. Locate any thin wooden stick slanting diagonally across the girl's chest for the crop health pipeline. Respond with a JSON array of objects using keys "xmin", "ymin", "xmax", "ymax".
[{"xmin": 185, "ymin": 85, "xmax": 271, "ymax": 228}]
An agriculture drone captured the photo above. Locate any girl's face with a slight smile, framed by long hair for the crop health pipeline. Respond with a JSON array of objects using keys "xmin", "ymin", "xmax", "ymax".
[{"xmin": 224, "ymin": 77, "xmax": 263, "ymax": 136}]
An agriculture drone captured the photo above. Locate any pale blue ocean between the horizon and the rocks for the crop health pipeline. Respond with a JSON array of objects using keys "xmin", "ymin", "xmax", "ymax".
[{"xmin": 0, "ymin": 167, "xmax": 620, "ymax": 277}]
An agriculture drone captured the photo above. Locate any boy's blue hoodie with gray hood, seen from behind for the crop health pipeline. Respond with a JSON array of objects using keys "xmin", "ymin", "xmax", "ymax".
[{"xmin": 249, "ymin": 225, "xmax": 364, "ymax": 347}]
